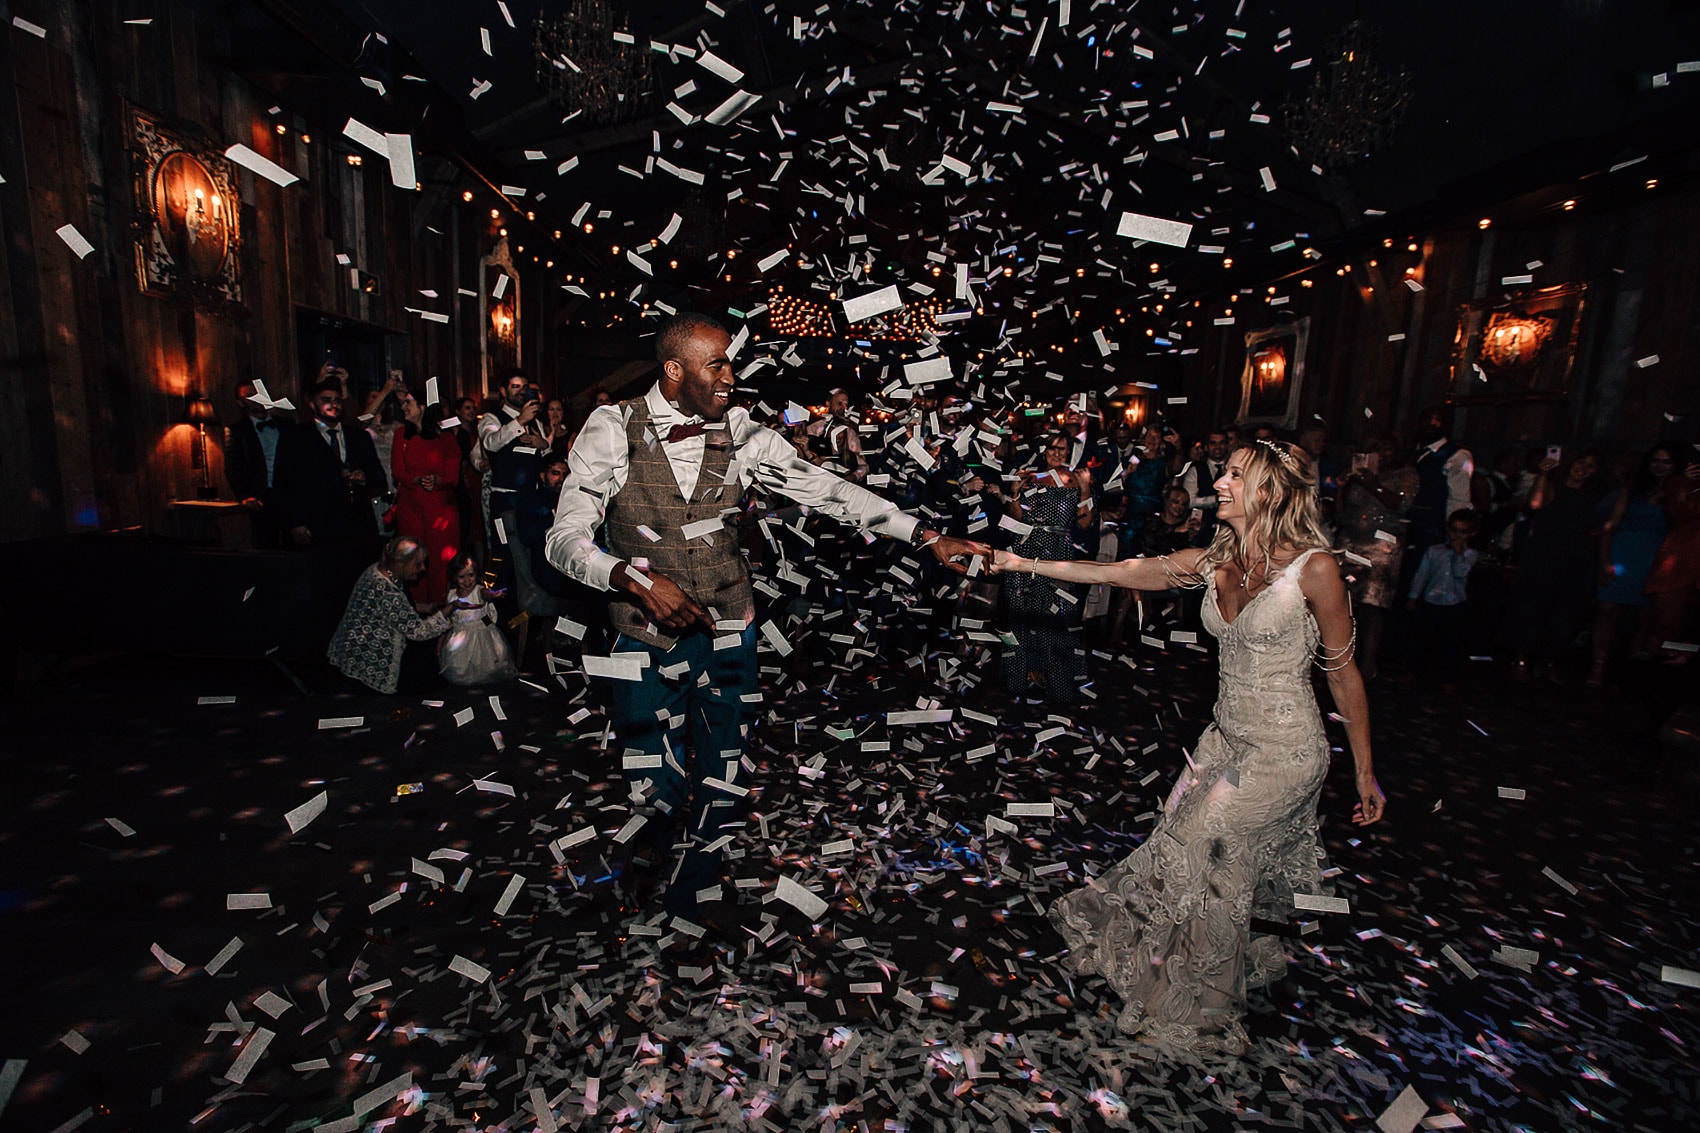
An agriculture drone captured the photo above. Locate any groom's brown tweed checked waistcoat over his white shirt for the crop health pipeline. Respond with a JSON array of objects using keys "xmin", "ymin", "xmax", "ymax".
[{"xmin": 607, "ymin": 398, "xmax": 755, "ymax": 648}]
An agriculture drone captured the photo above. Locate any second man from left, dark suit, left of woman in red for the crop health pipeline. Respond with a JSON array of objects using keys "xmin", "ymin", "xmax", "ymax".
[{"xmin": 272, "ymin": 381, "xmax": 389, "ymax": 546}]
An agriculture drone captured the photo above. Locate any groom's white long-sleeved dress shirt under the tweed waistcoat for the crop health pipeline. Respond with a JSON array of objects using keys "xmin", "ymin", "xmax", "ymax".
[{"xmin": 544, "ymin": 383, "xmax": 920, "ymax": 590}]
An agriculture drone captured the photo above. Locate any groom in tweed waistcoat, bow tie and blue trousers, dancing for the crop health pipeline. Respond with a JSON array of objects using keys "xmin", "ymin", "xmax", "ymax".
[{"xmin": 546, "ymin": 313, "xmax": 971, "ymax": 920}]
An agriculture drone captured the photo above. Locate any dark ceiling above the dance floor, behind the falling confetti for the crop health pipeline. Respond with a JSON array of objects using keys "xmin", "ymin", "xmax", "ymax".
[{"xmin": 216, "ymin": 0, "xmax": 1700, "ymax": 396}]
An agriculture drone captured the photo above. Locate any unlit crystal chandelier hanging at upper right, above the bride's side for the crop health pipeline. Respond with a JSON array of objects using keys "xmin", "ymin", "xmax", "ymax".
[{"xmin": 1282, "ymin": 20, "xmax": 1411, "ymax": 170}]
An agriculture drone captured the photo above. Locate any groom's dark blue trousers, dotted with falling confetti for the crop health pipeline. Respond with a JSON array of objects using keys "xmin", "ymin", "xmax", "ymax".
[{"xmin": 612, "ymin": 624, "xmax": 758, "ymax": 910}]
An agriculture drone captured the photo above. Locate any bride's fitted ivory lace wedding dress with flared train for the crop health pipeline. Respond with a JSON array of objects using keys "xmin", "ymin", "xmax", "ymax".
[{"xmin": 1049, "ymin": 551, "xmax": 1328, "ymax": 1053}]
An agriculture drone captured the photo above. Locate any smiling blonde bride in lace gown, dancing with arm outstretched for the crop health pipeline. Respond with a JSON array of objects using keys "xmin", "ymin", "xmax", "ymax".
[{"xmin": 983, "ymin": 433, "xmax": 1387, "ymax": 1053}]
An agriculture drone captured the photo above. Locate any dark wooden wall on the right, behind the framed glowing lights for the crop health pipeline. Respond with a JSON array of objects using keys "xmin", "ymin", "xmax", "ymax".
[{"xmin": 1165, "ymin": 176, "xmax": 1700, "ymax": 456}]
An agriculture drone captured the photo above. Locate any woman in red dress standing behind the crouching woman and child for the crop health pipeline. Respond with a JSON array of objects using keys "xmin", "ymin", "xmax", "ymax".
[{"xmin": 389, "ymin": 400, "xmax": 461, "ymax": 606}]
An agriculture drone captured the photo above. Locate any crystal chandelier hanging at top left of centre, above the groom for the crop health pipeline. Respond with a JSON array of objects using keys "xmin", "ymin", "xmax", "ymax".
[{"xmin": 532, "ymin": 0, "xmax": 653, "ymax": 126}]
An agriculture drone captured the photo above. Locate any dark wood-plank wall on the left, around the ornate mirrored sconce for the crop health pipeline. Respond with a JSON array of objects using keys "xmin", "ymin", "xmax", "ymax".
[{"xmin": 0, "ymin": 0, "xmax": 485, "ymax": 541}]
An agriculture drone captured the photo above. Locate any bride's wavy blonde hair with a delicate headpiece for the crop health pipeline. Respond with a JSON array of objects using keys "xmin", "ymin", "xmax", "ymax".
[{"xmin": 1199, "ymin": 432, "xmax": 1329, "ymax": 578}]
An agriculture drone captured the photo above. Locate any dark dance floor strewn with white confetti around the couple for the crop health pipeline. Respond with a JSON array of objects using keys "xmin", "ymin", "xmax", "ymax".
[{"xmin": 0, "ymin": 595, "xmax": 1700, "ymax": 1131}]
